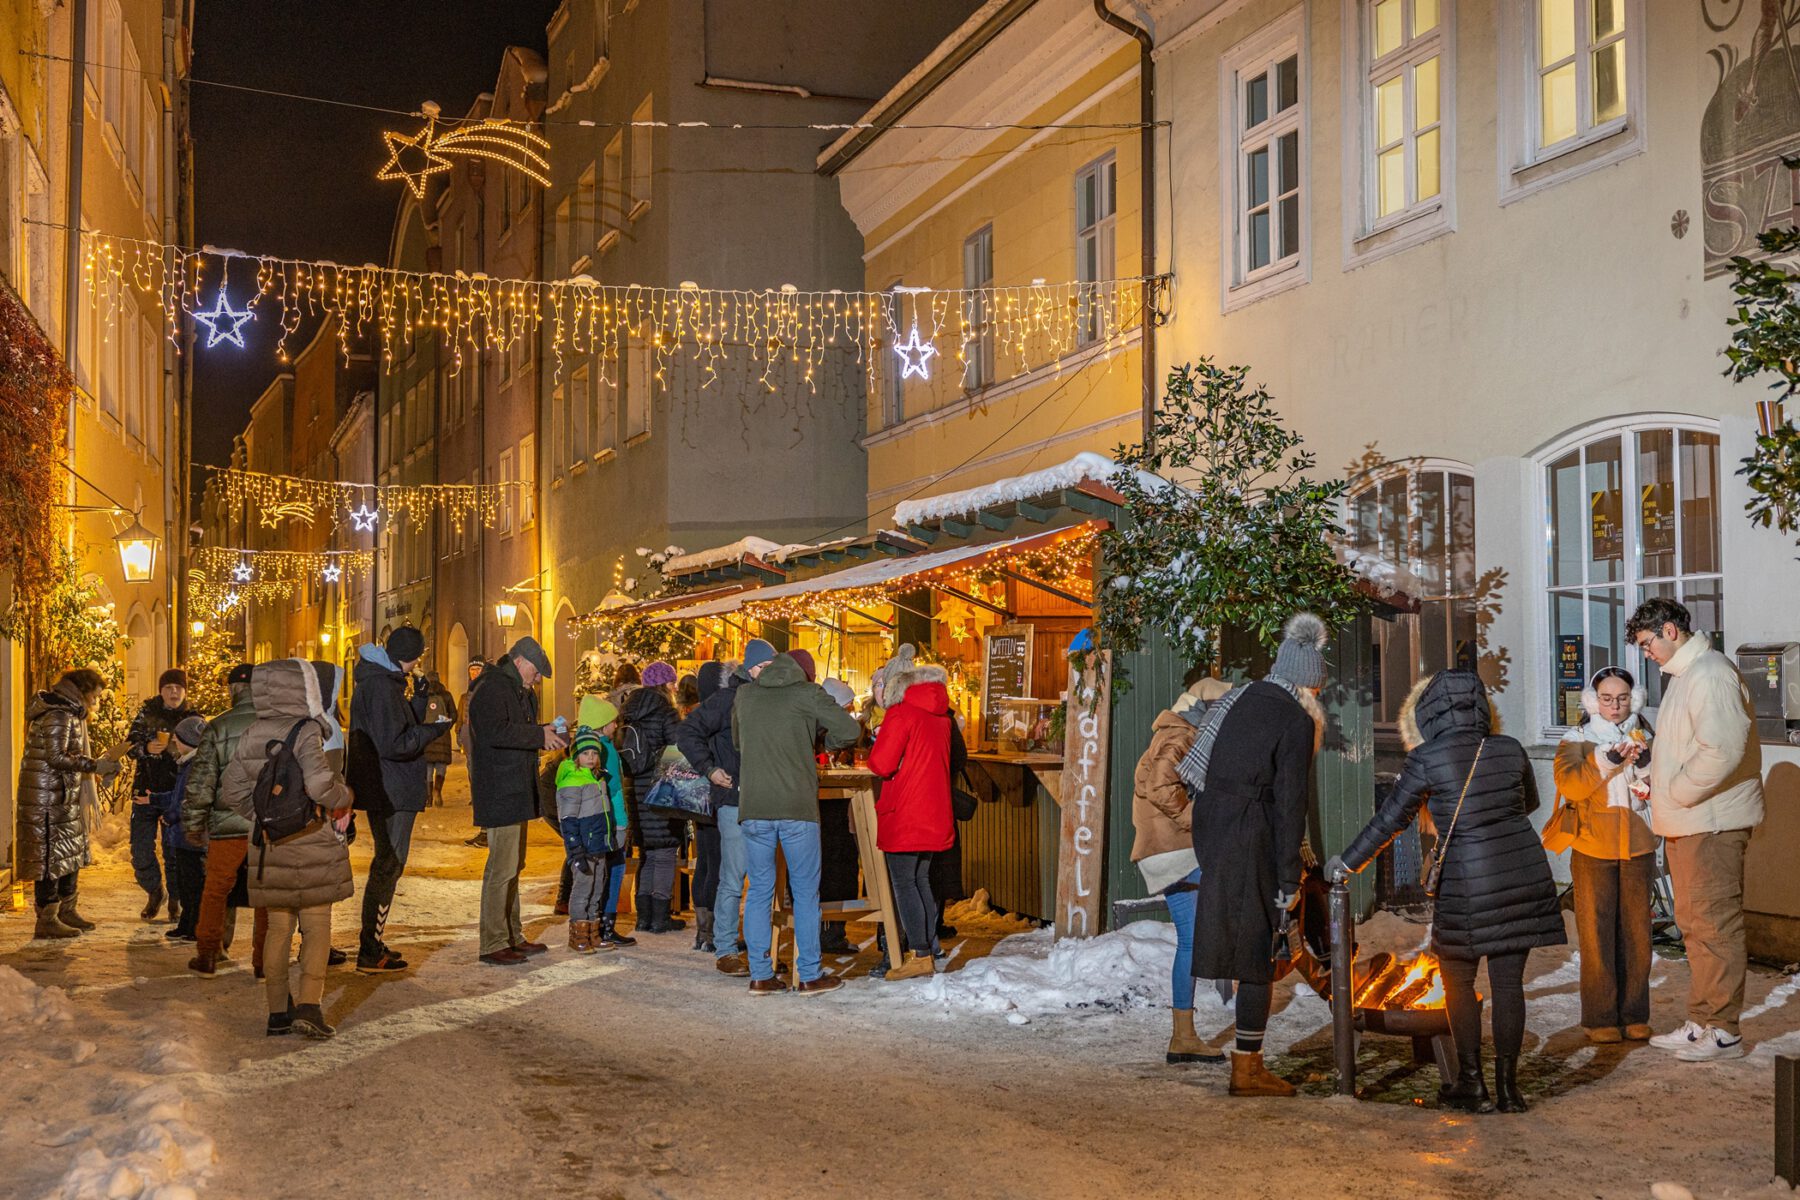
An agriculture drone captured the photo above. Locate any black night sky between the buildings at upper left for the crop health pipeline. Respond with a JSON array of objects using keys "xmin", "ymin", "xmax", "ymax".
[{"xmin": 193, "ymin": 0, "xmax": 556, "ymax": 495}]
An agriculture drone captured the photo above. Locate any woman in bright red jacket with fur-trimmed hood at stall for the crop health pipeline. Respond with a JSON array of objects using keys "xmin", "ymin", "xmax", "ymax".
[{"xmin": 869, "ymin": 666, "xmax": 968, "ymax": 979}]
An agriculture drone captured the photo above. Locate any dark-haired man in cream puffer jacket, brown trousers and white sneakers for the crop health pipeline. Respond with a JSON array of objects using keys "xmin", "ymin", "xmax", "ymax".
[{"xmin": 1625, "ymin": 597, "xmax": 1762, "ymax": 1061}]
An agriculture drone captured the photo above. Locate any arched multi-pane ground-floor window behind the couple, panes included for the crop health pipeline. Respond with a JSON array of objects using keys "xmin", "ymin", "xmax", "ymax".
[{"xmin": 1544, "ymin": 423, "xmax": 1724, "ymax": 725}]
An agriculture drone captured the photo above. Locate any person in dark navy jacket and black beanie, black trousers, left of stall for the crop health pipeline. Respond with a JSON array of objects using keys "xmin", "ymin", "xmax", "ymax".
[{"xmin": 346, "ymin": 624, "xmax": 452, "ymax": 975}]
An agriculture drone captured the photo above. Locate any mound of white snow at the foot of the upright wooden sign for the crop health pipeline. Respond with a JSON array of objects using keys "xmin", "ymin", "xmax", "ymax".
[{"xmin": 895, "ymin": 921, "xmax": 1175, "ymax": 1024}]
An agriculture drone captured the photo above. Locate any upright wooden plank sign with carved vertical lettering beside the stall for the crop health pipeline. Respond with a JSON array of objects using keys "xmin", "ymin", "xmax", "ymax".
[{"xmin": 1057, "ymin": 651, "xmax": 1112, "ymax": 939}]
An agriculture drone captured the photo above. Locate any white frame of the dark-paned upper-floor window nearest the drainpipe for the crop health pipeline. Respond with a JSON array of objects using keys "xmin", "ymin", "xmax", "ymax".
[{"xmin": 1219, "ymin": 7, "xmax": 1312, "ymax": 313}]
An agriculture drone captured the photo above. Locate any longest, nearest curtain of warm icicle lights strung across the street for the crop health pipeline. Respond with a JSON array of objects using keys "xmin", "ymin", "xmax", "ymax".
[{"xmin": 83, "ymin": 230, "xmax": 1147, "ymax": 401}]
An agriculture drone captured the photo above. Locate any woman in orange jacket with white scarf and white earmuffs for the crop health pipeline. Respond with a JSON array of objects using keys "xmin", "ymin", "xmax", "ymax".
[{"xmin": 1555, "ymin": 667, "xmax": 1656, "ymax": 1042}]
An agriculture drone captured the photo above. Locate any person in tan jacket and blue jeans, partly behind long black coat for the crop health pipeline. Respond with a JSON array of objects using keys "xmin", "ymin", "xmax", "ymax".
[{"xmin": 1130, "ymin": 673, "xmax": 1231, "ymax": 1063}]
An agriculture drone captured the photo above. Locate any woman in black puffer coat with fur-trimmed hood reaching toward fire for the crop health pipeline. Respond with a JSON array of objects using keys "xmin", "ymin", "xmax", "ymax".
[{"xmin": 1327, "ymin": 671, "xmax": 1568, "ymax": 1112}]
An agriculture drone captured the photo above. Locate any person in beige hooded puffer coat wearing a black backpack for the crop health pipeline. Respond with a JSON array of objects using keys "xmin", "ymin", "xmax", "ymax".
[{"xmin": 220, "ymin": 658, "xmax": 355, "ymax": 1038}]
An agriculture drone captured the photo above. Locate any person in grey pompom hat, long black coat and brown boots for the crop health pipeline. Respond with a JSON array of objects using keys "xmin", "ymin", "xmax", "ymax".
[{"xmin": 1181, "ymin": 612, "xmax": 1327, "ymax": 1096}]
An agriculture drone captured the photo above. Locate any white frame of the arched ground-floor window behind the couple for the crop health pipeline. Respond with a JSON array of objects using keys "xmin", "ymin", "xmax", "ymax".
[{"xmin": 1530, "ymin": 412, "xmax": 1728, "ymax": 741}]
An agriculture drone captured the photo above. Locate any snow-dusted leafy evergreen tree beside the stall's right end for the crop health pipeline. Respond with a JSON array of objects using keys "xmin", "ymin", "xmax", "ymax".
[{"xmin": 1096, "ymin": 358, "xmax": 1368, "ymax": 691}]
